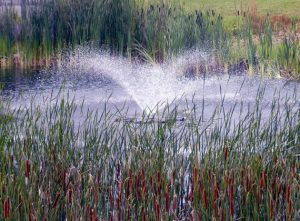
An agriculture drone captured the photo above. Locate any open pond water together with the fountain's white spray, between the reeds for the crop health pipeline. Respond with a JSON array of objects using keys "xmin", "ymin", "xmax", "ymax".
[{"xmin": 2, "ymin": 48, "xmax": 300, "ymax": 121}]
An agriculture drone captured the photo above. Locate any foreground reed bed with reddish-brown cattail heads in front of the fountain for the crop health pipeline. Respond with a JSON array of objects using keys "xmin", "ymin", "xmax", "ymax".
[{"xmin": 0, "ymin": 88, "xmax": 300, "ymax": 221}]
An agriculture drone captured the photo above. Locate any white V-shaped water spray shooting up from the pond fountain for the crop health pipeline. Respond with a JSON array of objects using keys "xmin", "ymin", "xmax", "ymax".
[{"xmin": 70, "ymin": 48, "xmax": 212, "ymax": 110}]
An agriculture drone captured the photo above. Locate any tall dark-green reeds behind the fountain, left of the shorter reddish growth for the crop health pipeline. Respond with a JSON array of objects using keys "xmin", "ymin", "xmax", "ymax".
[{"xmin": 0, "ymin": 0, "xmax": 226, "ymax": 64}]
